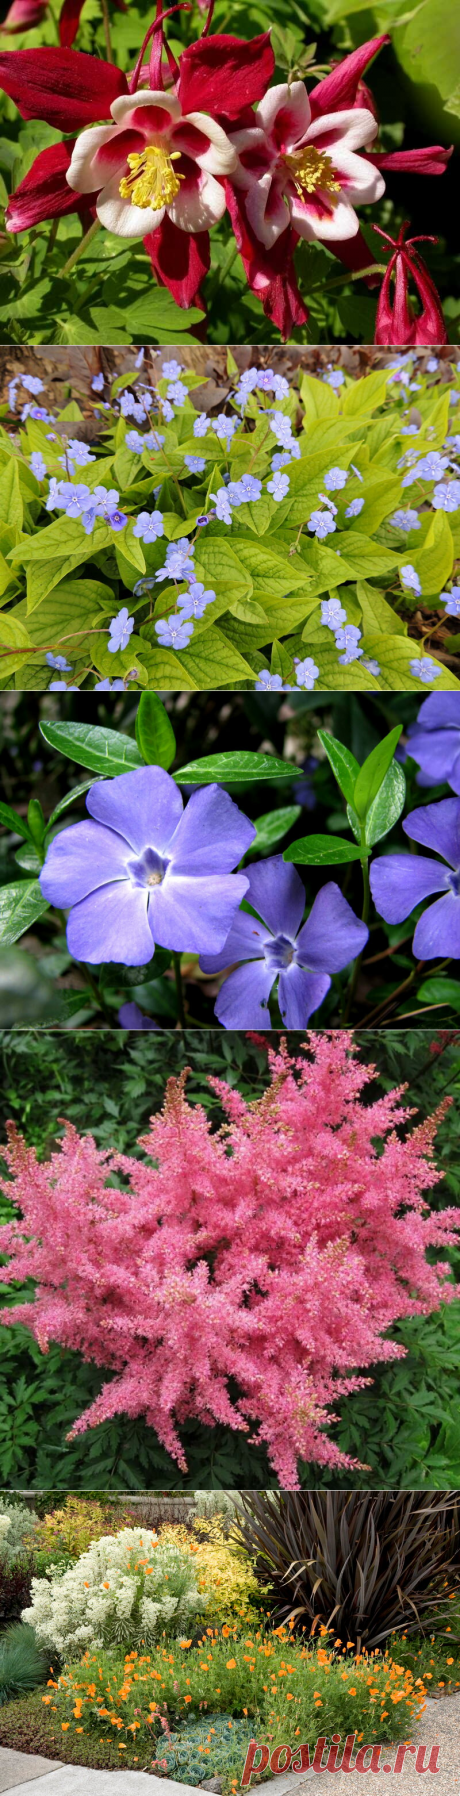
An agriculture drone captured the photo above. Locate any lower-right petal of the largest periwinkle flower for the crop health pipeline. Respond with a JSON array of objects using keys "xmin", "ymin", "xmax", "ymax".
[{"xmin": 149, "ymin": 867, "xmax": 248, "ymax": 954}]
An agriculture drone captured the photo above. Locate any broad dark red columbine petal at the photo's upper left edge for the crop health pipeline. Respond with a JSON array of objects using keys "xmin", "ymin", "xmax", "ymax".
[{"xmin": 0, "ymin": 45, "xmax": 128, "ymax": 133}]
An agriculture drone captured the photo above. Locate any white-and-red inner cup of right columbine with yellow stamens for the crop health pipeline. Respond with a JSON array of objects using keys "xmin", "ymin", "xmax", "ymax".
[{"xmin": 230, "ymin": 81, "xmax": 385, "ymax": 250}]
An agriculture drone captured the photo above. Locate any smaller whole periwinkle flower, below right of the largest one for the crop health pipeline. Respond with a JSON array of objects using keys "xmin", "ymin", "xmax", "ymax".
[{"xmin": 199, "ymin": 854, "xmax": 368, "ymax": 1029}]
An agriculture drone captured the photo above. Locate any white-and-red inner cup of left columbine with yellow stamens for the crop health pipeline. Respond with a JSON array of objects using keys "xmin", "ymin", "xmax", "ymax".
[{"xmin": 66, "ymin": 88, "xmax": 237, "ymax": 237}]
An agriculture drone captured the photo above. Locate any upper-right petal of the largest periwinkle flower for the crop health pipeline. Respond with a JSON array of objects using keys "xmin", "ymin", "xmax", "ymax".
[{"xmin": 169, "ymin": 785, "xmax": 255, "ymax": 875}]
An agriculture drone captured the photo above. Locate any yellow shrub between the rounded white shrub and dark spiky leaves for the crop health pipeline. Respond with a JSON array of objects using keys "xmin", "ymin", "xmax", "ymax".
[{"xmin": 158, "ymin": 1516, "xmax": 261, "ymax": 1624}]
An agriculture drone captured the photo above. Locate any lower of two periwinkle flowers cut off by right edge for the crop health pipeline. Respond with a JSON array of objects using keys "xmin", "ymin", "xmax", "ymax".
[{"xmin": 370, "ymin": 797, "xmax": 460, "ymax": 961}]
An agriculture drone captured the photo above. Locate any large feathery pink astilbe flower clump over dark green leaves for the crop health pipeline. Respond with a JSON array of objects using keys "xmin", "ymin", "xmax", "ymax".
[{"xmin": 0, "ymin": 1031, "xmax": 460, "ymax": 1489}]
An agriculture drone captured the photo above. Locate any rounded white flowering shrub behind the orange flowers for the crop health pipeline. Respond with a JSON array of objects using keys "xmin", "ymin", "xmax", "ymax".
[{"xmin": 22, "ymin": 1528, "xmax": 207, "ymax": 1658}]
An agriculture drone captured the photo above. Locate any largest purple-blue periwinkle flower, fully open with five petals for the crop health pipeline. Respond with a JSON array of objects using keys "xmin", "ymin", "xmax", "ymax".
[{"xmin": 40, "ymin": 767, "xmax": 255, "ymax": 966}]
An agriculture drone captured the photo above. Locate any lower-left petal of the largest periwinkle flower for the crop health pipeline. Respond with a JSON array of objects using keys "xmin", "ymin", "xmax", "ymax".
[{"xmin": 66, "ymin": 880, "xmax": 155, "ymax": 966}]
